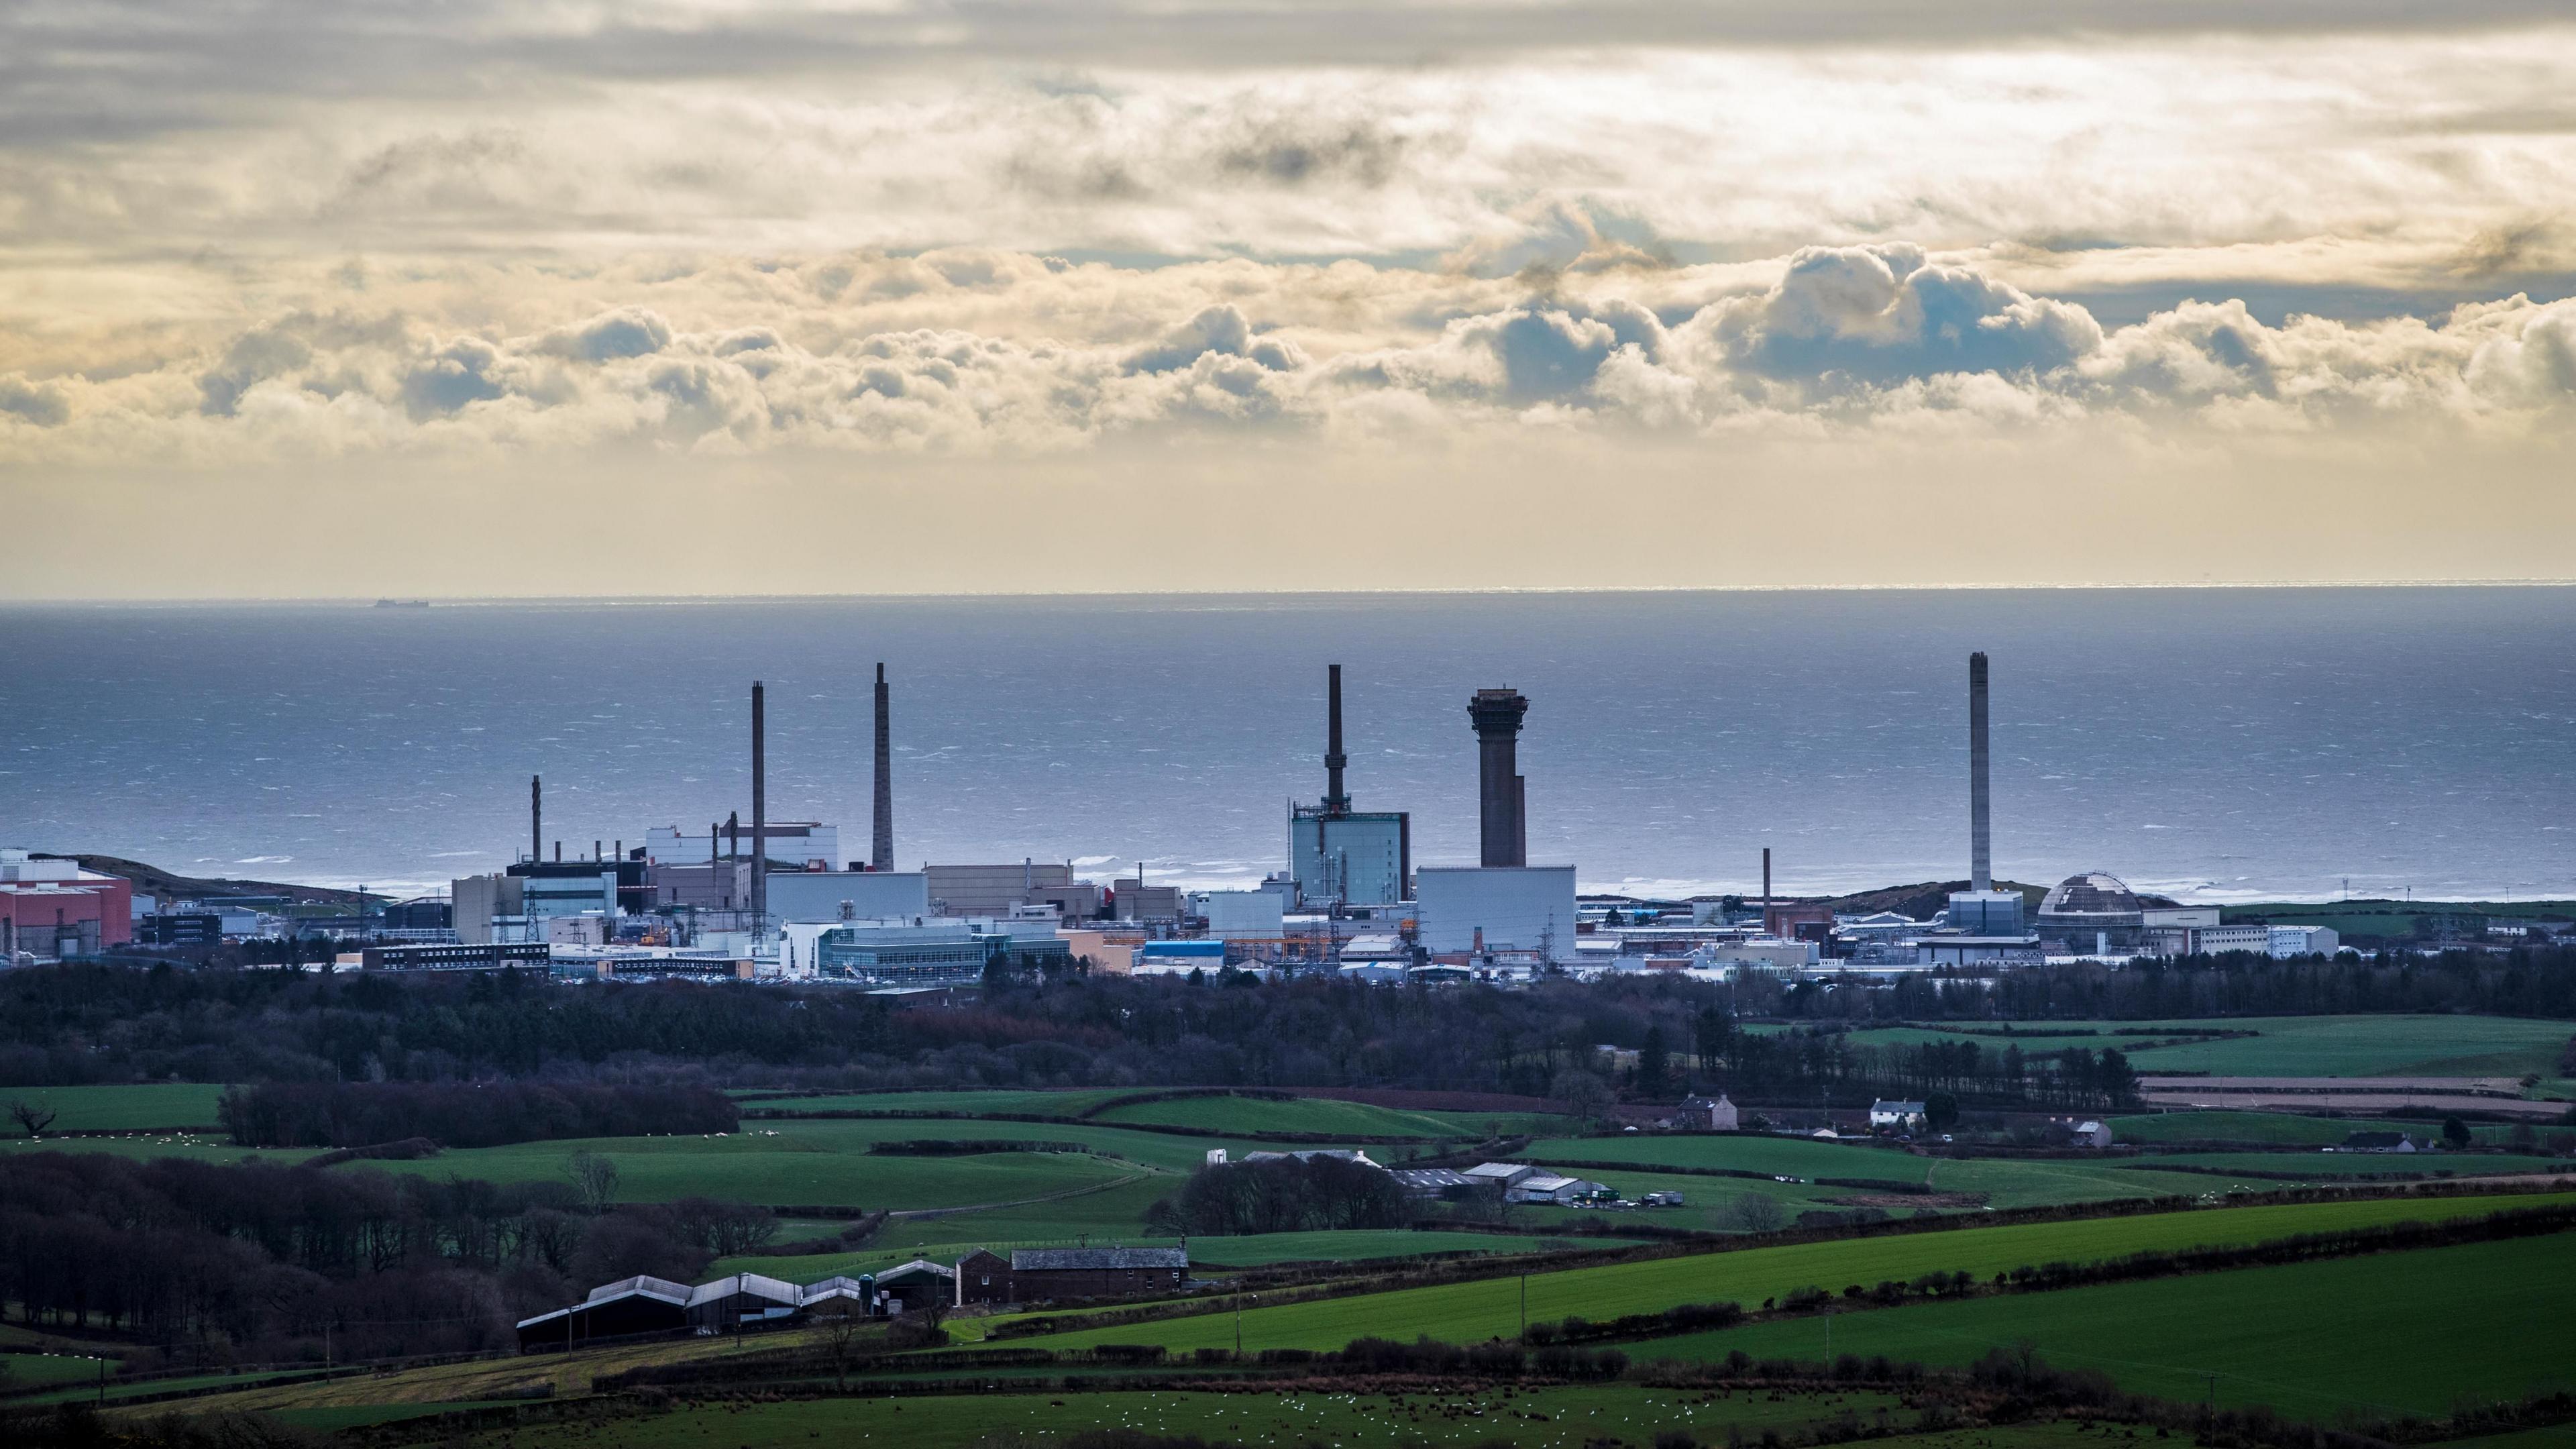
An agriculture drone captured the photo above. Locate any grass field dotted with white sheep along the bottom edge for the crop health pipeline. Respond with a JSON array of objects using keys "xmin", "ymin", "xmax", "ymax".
[{"xmin": 448, "ymin": 1385, "xmax": 1916, "ymax": 1449}]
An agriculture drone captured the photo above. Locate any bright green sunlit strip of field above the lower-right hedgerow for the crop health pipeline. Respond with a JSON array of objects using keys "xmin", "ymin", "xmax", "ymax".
[{"xmin": 1010, "ymin": 1194, "xmax": 2576, "ymax": 1348}]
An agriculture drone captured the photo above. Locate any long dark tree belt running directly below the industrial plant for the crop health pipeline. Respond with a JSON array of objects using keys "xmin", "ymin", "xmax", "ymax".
[{"xmin": 0, "ymin": 949, "xmax": 2576, "ymax": 1103}]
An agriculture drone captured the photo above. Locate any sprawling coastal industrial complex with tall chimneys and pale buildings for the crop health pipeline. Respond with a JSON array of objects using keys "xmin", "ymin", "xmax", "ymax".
[{"xmin": 20, "ymin": 652, "xmax": 2390, "ymax": 993}]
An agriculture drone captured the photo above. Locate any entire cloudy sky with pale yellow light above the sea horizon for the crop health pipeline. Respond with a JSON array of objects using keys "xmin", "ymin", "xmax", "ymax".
[{"xmin": 0, "ymin": 0, "xmax": 2576, "ymax": 598}]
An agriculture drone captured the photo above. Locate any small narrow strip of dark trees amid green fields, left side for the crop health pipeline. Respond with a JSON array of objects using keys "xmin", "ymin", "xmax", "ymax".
[{"xmin": 217, "ymin": 1083, "xmax": 742, "ymax": 1147}]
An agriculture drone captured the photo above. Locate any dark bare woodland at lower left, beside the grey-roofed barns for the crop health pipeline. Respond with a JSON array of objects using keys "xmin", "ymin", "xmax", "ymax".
[{"xmin": 0, "ymin": 1152, "xmax": 778, "ymax": 1369}]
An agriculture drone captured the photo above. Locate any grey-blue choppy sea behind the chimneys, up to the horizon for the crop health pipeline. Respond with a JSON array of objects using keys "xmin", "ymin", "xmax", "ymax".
[{"xmin": 0, "ymin": 588, "xmax": 2576, "ymax": 902}]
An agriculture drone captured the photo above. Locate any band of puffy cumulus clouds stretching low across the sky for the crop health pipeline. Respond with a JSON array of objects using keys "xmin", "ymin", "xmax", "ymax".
[{"xmin": 0, "ymin": 242, "xmax": 2576, "ymax": 462}]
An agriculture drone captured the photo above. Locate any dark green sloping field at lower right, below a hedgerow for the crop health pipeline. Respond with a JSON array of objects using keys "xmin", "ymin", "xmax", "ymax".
[{"xmin": 1631, "ymin": 1232, "xmax": 2576, "ymax": 1418}]
